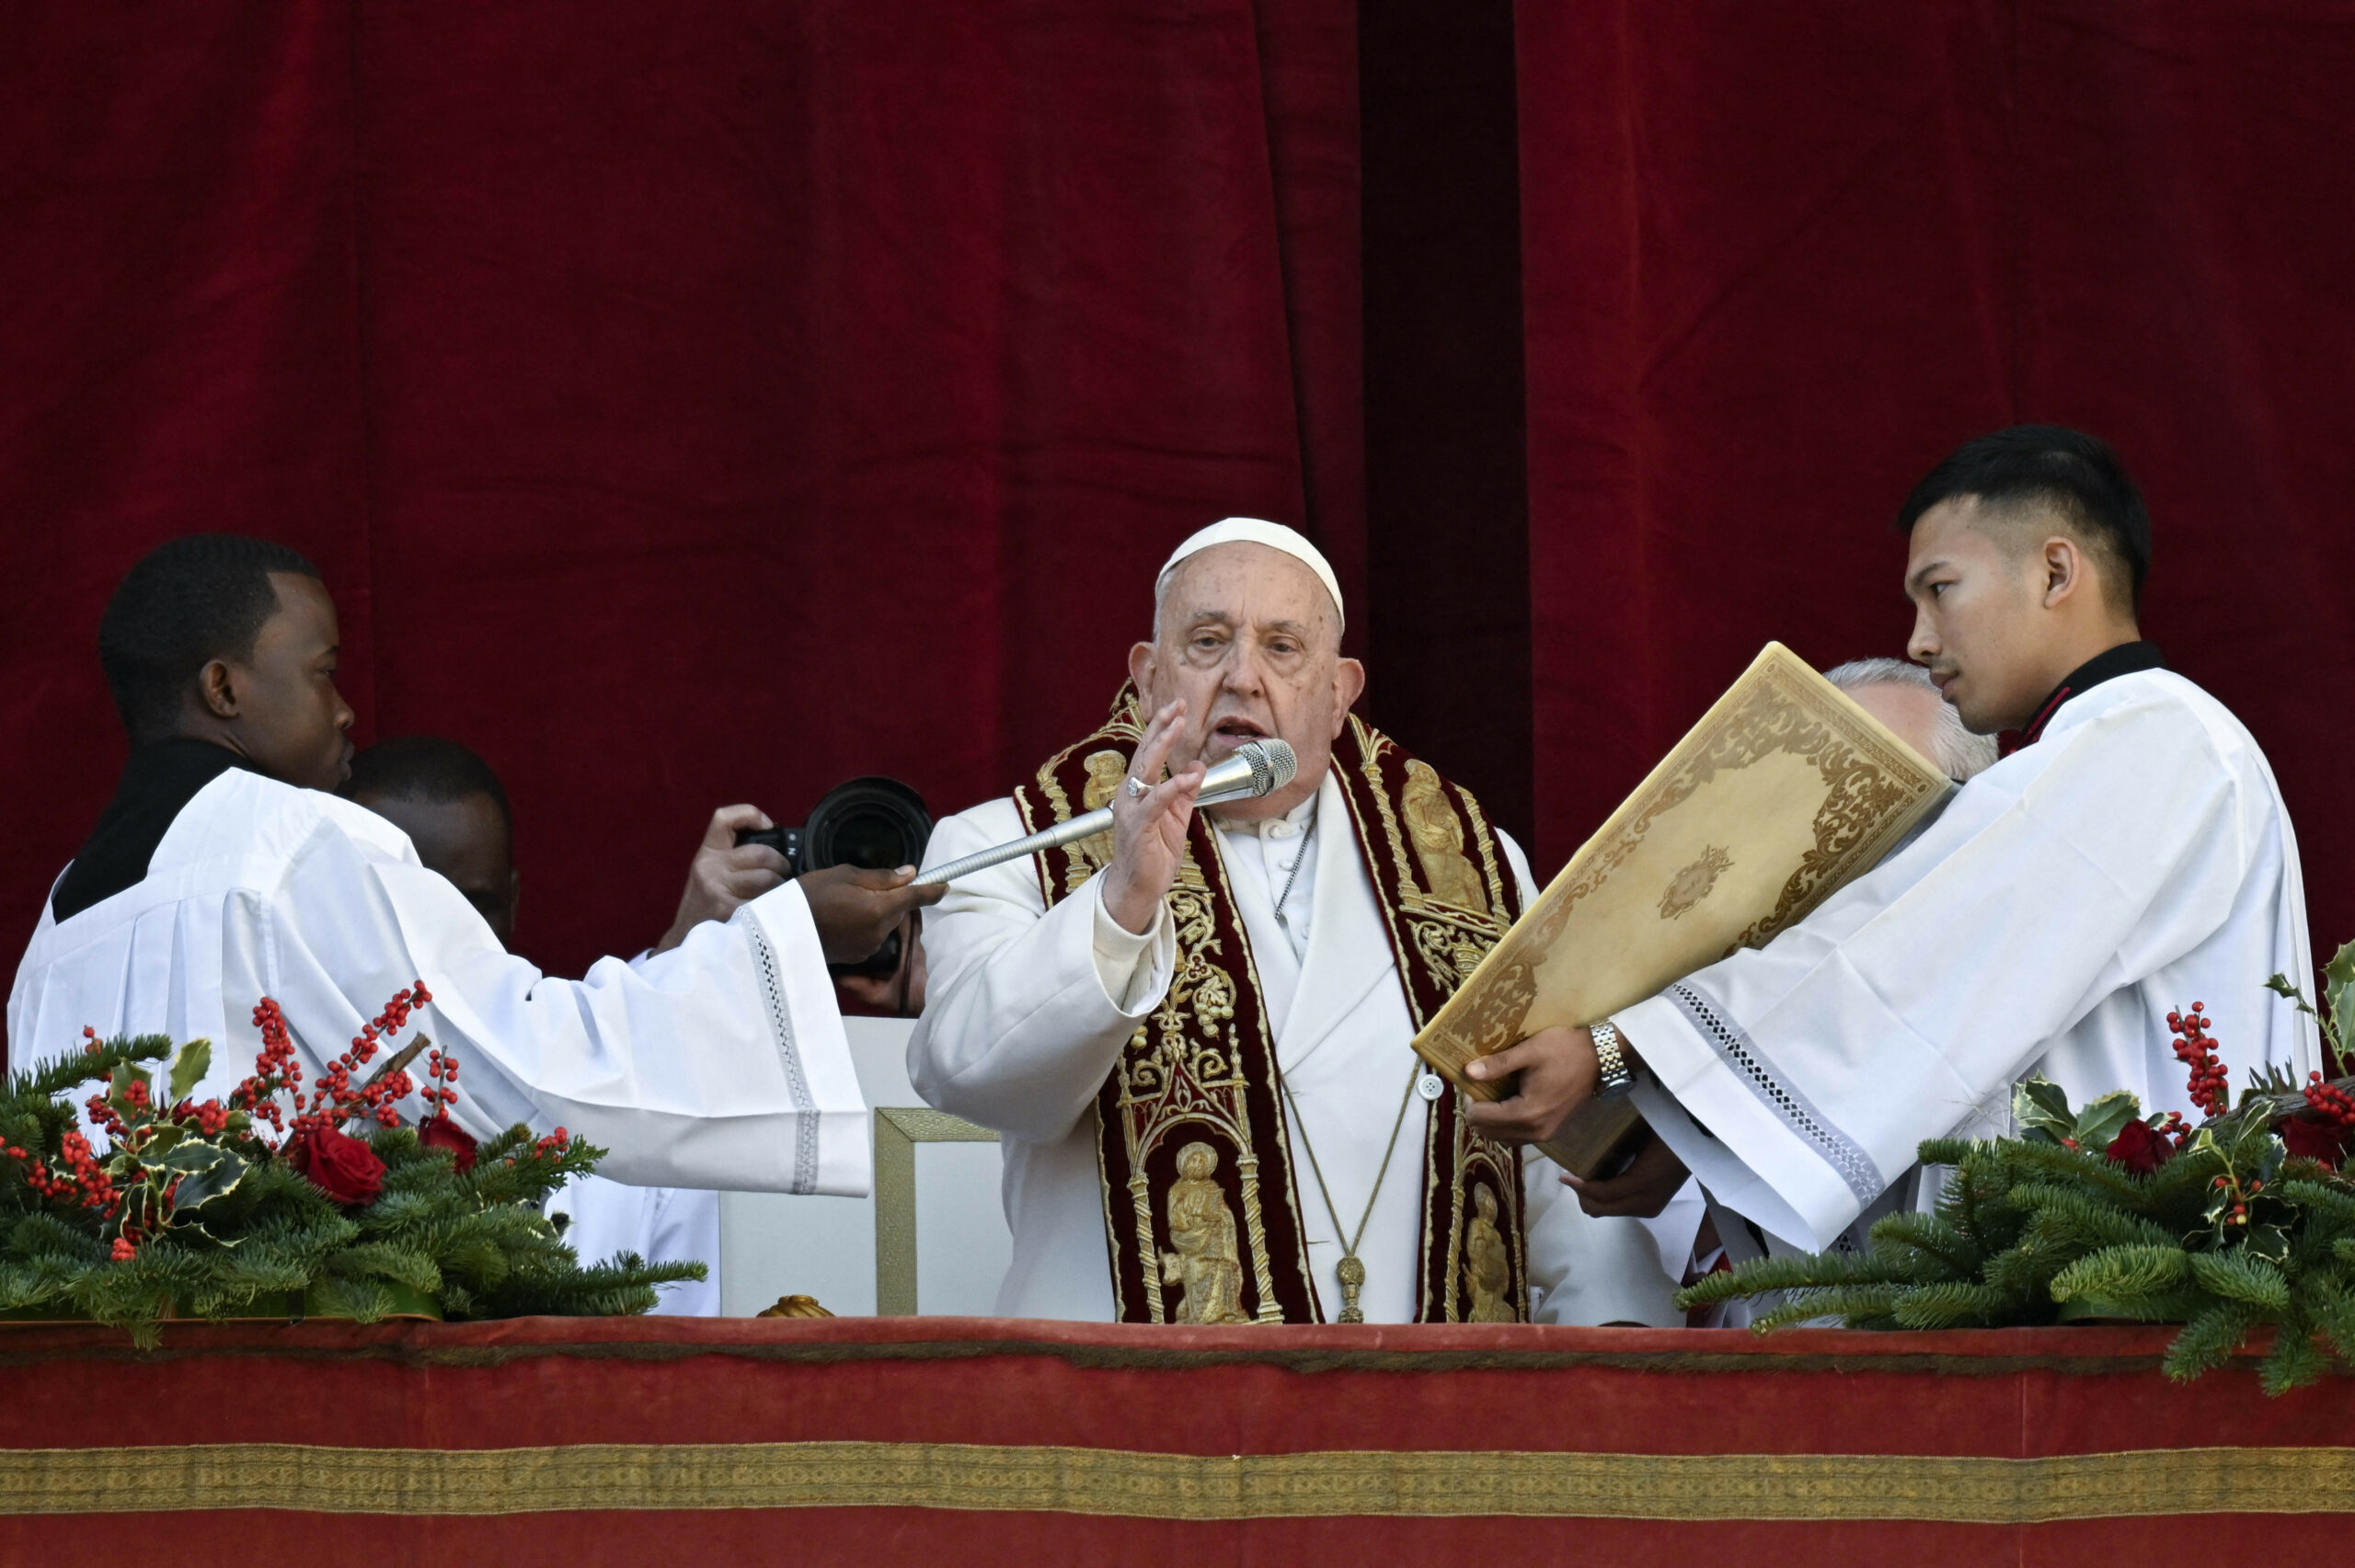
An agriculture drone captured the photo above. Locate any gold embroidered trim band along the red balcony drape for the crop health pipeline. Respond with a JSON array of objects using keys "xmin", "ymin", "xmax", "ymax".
[{"xmin": 0, "ymin": 1443, "xmax": 2355, "ymax": 1526}]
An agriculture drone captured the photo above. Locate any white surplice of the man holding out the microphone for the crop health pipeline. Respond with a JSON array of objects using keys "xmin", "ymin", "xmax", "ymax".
[{"xmin": 7, "ymin": 768, "xmax": 869, "ymax": 1196}]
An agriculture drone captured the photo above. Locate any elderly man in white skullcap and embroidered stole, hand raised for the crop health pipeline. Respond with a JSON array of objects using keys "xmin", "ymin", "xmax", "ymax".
[{"xmin": 909, "ymin": 518, "xmax": 1679, "ymax": 1323}]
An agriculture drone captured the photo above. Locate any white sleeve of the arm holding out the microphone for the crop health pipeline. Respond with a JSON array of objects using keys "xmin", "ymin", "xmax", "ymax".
[{"xmin": 224, "ymin": 819, "xmax": 869, "ymax": 1196}]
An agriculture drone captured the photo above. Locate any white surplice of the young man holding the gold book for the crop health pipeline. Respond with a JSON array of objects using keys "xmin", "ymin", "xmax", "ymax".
[{"xmin": 1618, "ymin": 671, "xmax": 2320, "ymax": 1250}]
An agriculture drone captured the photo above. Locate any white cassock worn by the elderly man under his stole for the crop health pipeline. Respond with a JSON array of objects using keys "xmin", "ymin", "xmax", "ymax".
[{"xmin": 907, "ymin": 774, "xmax": 1683, "ymax": 1323}]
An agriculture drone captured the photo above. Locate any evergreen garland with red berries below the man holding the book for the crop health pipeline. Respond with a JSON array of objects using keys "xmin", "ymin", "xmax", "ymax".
[{"xmin": 1677, "ymin": 960, "xmax": 2355, "ymax": 1394}]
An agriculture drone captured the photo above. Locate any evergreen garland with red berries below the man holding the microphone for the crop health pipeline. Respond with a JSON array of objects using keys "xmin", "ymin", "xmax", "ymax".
[{"xmin": 0, "ymin": 1020, "xmax": 704, "ymax": 1349}]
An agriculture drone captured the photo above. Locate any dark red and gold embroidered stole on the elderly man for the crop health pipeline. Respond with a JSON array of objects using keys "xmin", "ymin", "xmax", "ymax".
[{"xmin": 1015, "ymin": 690, "xmax": 1528, "ymax": 1323}]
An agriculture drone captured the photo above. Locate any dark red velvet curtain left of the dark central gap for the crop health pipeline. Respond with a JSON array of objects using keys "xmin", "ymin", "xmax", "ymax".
[{"xmin": 0, "ymin": 0, "xmax": 1363, "ymax": 1049}]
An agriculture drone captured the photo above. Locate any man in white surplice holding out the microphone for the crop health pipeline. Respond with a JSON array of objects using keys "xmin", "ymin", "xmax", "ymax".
[{"xmin": 7, "ymin": 534, "xmax": 947, "ymax": 1194}]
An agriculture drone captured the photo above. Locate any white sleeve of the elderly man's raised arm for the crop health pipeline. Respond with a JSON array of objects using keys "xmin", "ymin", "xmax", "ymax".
[{"xmin": 907, "ymin": 803, "xmax": 1178, "ymax": 1142}]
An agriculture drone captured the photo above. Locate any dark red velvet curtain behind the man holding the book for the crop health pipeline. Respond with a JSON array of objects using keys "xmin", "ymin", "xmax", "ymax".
[{"xmin": 1519, "ymin": 0, "xmax": 2355, "ymax": 979}]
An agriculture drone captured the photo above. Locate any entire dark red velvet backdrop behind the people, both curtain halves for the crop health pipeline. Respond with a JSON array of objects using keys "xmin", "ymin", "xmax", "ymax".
[{"xmin": 0, "ymin": 0, "xmax": 2355, "ymax": 1054}]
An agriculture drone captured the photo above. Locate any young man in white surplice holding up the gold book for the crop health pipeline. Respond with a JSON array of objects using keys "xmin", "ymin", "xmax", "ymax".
[{"xmin": 1475, "ymin": 426, "xmax": 2320, "ymax": 1248}]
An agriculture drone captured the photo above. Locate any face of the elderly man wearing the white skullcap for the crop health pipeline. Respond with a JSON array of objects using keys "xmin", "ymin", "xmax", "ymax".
[{"xmin": 1128, "ymin": 544, "xmax": 1366, "ymax": 821}]
